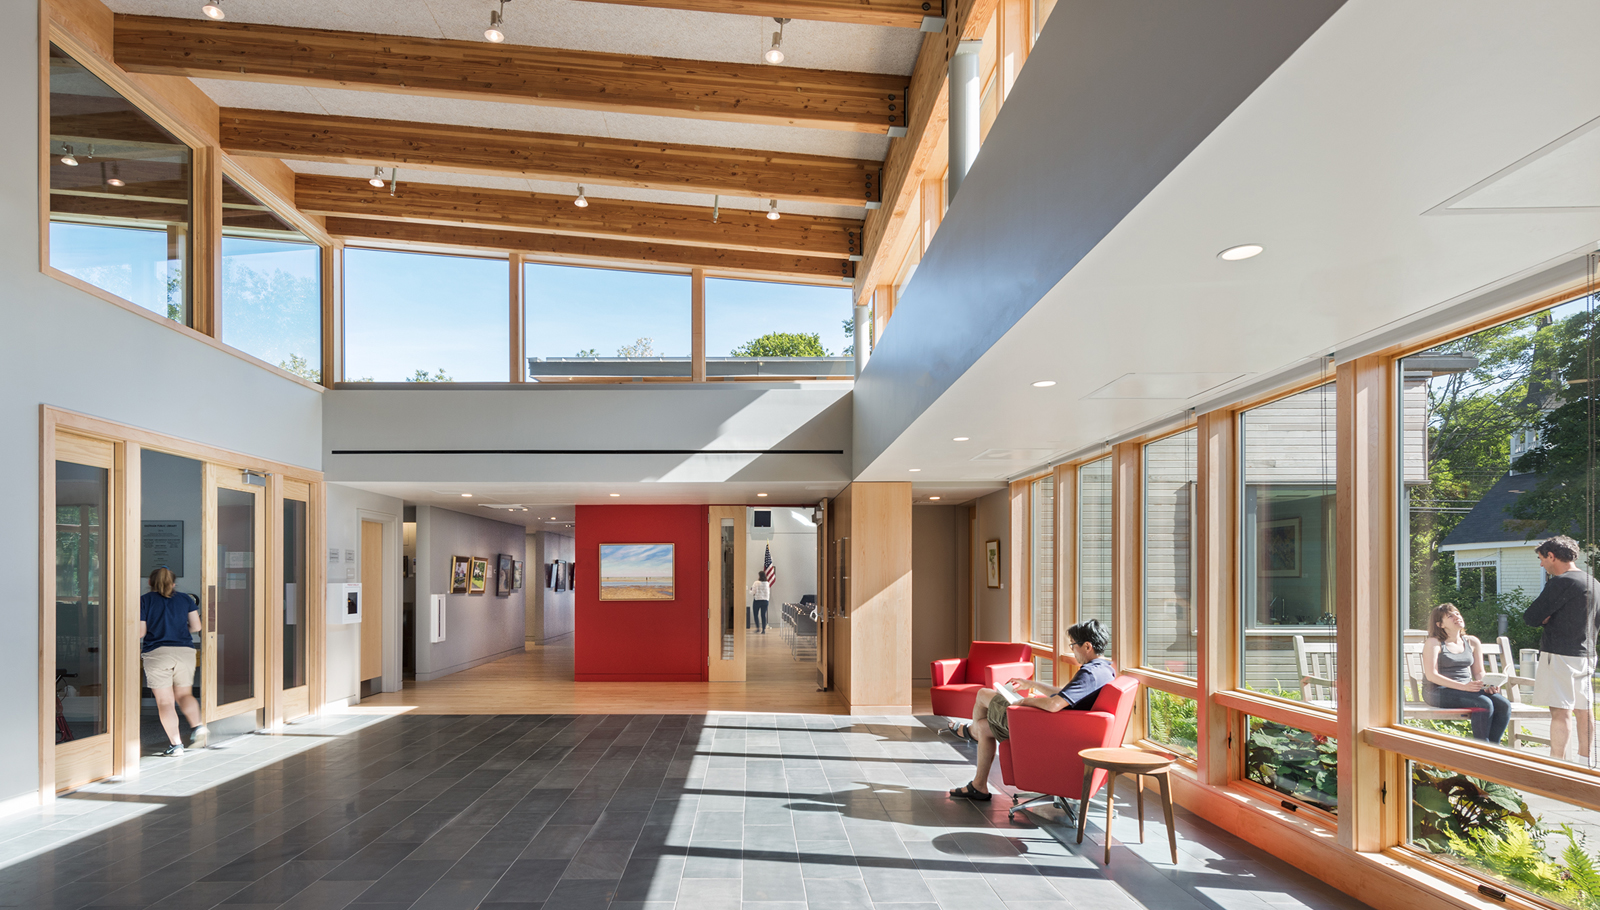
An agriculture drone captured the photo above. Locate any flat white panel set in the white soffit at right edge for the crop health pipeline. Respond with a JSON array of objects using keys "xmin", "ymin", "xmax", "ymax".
[{"xmin": 1430, "ymin": 118, "xmax": 1600, "ymax": 214}]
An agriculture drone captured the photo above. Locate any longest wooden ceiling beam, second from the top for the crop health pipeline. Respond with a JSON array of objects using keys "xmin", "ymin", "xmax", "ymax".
[{"xmin": 115, "ymin": 14, "xmax": 906, "ymax": 134}]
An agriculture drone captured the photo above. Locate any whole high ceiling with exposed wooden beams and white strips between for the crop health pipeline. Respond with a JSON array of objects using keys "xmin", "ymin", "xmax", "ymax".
[{"xmin": 107, "ymin": 0, "xmax": 938, "ymax": 281}]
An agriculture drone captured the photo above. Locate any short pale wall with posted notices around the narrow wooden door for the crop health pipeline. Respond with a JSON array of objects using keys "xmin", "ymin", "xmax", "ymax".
[{"xmin": 322, "ymin": 483, "xmax": 405, "ymax": 704}]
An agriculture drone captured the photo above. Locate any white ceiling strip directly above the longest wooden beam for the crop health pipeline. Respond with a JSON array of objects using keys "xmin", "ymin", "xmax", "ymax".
[{"xmin": 106, "ymin": 0, "xmax": 922, "ymax": 75}]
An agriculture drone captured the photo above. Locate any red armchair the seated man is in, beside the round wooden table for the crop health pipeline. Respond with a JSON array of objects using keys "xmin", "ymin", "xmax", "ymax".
[{"xmin": 1000, "ymin": 677, "xmax": 1139, "ymax": 816}]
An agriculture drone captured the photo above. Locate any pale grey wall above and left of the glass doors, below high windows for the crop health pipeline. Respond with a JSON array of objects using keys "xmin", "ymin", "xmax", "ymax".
[{"xmin": 0, "ymin": 0, "xmax": 322, "ymax": 804}]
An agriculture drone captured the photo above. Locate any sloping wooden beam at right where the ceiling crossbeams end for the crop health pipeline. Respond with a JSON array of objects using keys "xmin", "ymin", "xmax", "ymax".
[{"xmin": 856, "ymin": 0, "xmax": 1000, "ymax": 302}]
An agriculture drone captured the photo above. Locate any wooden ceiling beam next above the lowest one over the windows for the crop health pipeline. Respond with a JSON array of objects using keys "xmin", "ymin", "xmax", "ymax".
[{"xmin": 305, "ymin": 174, "xmax": 861, "ymax": 259}]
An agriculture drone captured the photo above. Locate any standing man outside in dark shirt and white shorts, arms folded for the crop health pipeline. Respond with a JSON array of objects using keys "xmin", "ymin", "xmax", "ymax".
[{"xmin": 1522, "ymin": 534, "xmax": 1600, "ymax": 764}]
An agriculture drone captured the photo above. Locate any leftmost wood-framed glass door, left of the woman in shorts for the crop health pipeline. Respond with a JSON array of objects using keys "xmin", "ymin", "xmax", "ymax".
[{"xmin": 46, "ymin": 433, "xmax": 118, "ymax": 790}]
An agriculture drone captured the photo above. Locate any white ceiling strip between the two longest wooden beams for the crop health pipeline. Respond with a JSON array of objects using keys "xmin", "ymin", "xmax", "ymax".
[{"xmin": 194, "ymin": 78, "xmax": 890, "ymax": 160}]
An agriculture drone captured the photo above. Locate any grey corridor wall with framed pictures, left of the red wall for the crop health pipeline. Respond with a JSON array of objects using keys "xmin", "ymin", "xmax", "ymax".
[{"xmin": 416, "ymin": 505, "xmax": 528, "ymax": 681}]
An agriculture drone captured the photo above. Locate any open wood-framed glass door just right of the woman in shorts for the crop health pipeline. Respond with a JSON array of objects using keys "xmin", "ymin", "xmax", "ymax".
[{"xmin": 200, "ymin": 464, "xmax": 267, "ymax": 723}]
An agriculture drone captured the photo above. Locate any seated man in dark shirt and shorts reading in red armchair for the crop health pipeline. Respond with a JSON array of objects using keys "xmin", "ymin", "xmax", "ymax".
[{"xmin": 950, "ymin": 619, "xmax": 1117, "ymax": 801}]
